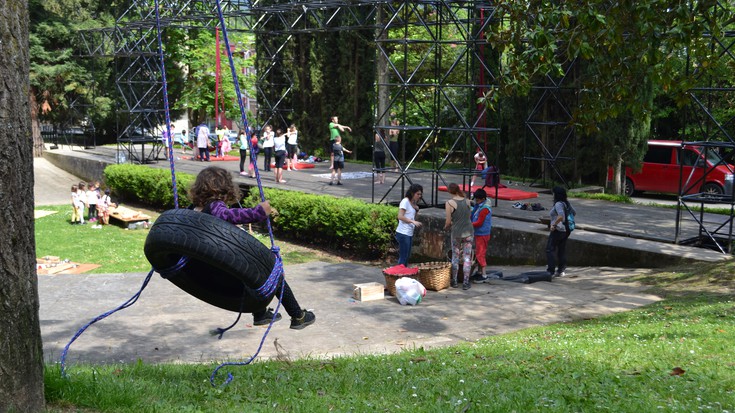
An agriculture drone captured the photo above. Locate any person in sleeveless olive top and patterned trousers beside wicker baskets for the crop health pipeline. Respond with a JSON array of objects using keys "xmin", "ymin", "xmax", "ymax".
[{"xmin": 444, "ymin": 182, "xmax": 474, "ymax": 290}]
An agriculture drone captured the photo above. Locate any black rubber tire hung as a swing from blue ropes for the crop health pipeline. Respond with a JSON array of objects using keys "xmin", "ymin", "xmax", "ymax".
[{"xmin": 144, "ymin": 209, "xmax": 275, "ymax": 313}]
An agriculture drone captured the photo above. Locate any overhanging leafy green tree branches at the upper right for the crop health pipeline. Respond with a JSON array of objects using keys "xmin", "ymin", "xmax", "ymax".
[{"xmin": 486, "ymin": 0, "xmax": 717, "ymax": 190}]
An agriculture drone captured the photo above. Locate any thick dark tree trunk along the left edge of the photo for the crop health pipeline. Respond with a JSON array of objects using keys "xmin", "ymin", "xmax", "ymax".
[{"xmin": 0, "ymin": 0, "xmax": 44, "ymax": 412}]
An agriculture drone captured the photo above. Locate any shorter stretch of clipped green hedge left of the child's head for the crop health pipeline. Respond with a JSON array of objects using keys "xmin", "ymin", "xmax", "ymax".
[{"xmin": 104, "ymin": 164, "xmax": 195, "ymax": 208}]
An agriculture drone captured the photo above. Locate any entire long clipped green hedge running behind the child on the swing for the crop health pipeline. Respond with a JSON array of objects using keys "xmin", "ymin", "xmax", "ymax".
[{"xmin": 104, "ymin": 164, "xmax": 398, "ymax": 257}]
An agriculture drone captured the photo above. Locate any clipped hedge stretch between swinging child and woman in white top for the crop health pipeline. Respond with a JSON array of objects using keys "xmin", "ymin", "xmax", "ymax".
[{"xmin": 248, "ymin": 189, "xmax": 398, "ymax": 256}]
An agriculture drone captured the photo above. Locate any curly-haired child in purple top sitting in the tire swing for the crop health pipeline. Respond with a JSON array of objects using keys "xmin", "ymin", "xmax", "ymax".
[{"xmin": 189, "ymin": 166, "xmax": 316, "ymax": 330}]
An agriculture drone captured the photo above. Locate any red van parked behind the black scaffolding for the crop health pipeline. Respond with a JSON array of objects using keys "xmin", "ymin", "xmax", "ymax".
[{"xmin": 608, "ymin": 141, "xmax": 735, "ymax": 196}]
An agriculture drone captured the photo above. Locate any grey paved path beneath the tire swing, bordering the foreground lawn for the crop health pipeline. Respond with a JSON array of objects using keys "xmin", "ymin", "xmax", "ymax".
[{"xmin": 39, "ymin": 262, "xmax": 658, "ymax": 363}]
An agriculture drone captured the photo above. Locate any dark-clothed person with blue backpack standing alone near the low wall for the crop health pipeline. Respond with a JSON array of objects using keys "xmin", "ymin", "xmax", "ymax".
[{"xmin": 546, "ymin": 186, "xmax": 577, "ymax": 277}]
